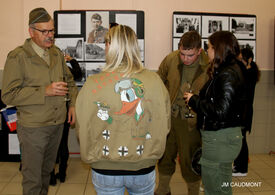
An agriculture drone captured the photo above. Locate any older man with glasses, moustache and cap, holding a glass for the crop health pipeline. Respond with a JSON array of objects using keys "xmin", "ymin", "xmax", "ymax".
[{"xmin": 2, "ymin": 8, "xmax": 77, "ymax": 195}]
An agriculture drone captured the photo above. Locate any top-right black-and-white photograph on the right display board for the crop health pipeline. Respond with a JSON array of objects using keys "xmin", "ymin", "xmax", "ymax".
[{"xmin": 230, "ymin": 17, "xmax": 256, "ymax": 39}]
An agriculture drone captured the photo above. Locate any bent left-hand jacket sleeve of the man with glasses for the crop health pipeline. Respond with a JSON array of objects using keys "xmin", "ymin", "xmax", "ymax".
[{"xmin": 1, "ymin": 54, "xmax": 45, "ymax": 106}]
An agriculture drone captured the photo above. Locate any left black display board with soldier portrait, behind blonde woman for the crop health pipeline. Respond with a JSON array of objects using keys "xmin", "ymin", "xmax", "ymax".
[{"xmin": 54, "ymin": 10, "xmax": 145, "ymax": 86}]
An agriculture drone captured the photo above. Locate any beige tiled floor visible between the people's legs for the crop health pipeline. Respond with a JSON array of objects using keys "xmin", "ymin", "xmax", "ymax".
[{"xmin": 0, "ymin": 154, "xmax": 275, "ymax": 195}]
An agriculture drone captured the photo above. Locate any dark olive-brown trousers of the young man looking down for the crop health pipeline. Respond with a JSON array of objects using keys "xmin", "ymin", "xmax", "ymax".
[{"xmin": 158, "ymin": 117, "xmax": 201, "ymax": 183}]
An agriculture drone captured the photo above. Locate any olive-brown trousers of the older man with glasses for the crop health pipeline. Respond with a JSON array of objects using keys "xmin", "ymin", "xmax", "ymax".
[{"xmin": 17, "ymin": 123, "xmax": 63, "ymax": 195}]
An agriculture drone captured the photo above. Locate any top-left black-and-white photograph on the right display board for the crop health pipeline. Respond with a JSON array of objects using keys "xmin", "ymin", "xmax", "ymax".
[{"xmin": 173, "ymin": 14, "xmax": 201, "ymax": 37}]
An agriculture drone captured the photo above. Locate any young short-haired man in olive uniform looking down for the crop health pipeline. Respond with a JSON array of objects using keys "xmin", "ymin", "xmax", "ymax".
[{"xmin": 155, "ymin": 31, "xmax": 209, "ymax": 195}]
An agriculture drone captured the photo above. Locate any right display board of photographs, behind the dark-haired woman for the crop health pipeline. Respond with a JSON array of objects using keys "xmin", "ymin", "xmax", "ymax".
[{"xmin": 172, "ymin": 11, "xmax": 256, "ymax": 58}]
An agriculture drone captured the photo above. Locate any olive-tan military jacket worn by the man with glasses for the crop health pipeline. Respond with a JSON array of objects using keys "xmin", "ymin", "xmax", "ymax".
[{"xmin": 2, "ymin": 39, "xmax": 77, "ymax": 127}]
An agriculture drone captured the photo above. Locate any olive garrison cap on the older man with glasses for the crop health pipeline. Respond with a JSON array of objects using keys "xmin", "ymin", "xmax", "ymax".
[{"xmin": 29, "ymin": 7, "xmax": 51, "ymax": 25}]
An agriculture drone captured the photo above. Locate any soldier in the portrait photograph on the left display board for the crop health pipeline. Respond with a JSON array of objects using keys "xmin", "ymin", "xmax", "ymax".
[{"xmin": 87, "ymin": 13, "xmax": 108, "ymax": 43}]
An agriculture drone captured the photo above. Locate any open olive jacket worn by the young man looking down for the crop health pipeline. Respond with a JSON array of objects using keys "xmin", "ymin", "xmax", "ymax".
[{"xmin": 157, "ymin": 50, "xmax": 209, "ymax": 105}]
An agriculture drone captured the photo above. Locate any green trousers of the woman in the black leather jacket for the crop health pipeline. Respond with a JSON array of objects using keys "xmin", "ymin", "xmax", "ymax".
[{"xmin": 200, "ymin": 127, "xmax": 242, "ymax": 195}]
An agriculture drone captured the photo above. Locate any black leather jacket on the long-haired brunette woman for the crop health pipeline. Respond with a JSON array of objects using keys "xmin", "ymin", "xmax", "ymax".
[{"xmin": 188, "ymin": 59, "xmax": 247, "ymax": 131}]
